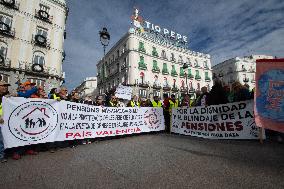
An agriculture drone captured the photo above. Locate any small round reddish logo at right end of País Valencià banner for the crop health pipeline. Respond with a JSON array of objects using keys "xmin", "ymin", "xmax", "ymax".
[{"xmin": 144, "ymin": 108, "xmax": 162, "ymax": 129}]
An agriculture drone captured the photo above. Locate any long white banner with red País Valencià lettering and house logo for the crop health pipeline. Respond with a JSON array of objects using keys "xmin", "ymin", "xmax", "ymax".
[{"xmin": 1, "ymin": 97, "xmax": 165, "ymax": 148}]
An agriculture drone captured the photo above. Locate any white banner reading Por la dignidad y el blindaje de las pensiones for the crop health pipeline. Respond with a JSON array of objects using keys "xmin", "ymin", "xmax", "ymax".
[{"xmin": 171, "ymin": 101, "xmax": 265, "ymax": 139}]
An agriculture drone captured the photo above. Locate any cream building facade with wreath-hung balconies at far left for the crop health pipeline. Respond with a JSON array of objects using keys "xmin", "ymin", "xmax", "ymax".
[{"xmin": 0, "ymin": 0, "xmax": 68, "ymax": 91}]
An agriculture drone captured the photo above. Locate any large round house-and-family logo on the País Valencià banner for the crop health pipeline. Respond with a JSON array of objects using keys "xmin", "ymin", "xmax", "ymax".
[{"xmin": 8, "ymin": 101, "xmax": 58, "ymax": 141}]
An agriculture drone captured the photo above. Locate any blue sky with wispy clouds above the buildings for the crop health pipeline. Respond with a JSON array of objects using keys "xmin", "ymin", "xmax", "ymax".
[{"xmin": 63, "ymin": 0, "xmax": 284, "ymax": 89}]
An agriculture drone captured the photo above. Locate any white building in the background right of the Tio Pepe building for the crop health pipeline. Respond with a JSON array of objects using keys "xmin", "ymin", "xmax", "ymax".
[{"xmin": 212, "ymin": 55, "xmax": 274, "ymax": 89}]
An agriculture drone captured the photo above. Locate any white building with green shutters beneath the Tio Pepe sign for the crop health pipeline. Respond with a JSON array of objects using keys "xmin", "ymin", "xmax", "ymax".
[{"xmin": 97, "ymin": 9, "xmax": 213, "ymax": 97}]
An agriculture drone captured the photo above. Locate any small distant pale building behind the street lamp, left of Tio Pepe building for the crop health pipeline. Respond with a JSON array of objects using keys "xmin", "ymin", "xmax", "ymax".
[{"xmin": 75, "ymin": 77, "xmax": 97, "ymax": 98}]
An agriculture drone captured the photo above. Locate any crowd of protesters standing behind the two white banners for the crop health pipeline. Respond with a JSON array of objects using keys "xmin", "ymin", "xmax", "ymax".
[{"xmin": 0, "ymin": 80, "xmax": 282, "ymax": 162}]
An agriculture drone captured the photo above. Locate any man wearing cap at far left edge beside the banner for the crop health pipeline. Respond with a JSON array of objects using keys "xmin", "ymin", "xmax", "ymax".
[{"xmin": 0, "ymin": 81, "xmax": 10, "ymax": 163}]
